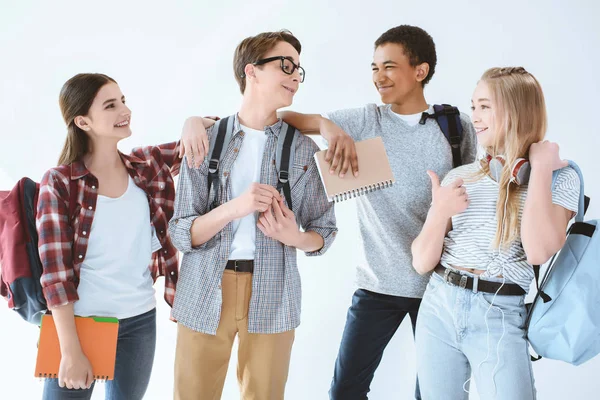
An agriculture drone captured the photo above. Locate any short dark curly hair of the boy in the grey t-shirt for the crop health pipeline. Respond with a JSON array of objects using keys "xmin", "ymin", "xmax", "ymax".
[{"xmin": 375, "ymin": 25, "xmax": 437, "ymax": 86}]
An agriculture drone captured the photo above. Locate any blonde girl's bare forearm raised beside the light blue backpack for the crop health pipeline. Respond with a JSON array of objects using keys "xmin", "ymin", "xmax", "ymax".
[{"xmin": 521, "ymin": 168, "xmax": 566, "ymax": 265}]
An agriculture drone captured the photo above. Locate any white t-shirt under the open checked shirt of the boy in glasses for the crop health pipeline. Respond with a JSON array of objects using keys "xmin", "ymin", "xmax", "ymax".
[{"xmin": 229, "ymin": 125, "xmax": 267, "ymax": 260}]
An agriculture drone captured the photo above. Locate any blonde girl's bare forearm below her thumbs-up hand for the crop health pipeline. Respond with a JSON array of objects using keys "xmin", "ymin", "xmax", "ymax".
[{"xmin": 411, "ymin": 208, "xmax": 450, "ymax": 274}]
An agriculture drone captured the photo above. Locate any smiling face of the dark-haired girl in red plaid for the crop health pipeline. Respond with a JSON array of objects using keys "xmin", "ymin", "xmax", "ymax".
[{"xmin": 75, "ymin": 82, "xmax": 131, "ymax": 140}]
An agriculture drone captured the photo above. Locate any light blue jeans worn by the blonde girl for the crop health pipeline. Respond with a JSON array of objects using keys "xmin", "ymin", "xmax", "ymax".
[{"xmin": 416, "ymin": 272, "xmax": 536, "ymax": 400}]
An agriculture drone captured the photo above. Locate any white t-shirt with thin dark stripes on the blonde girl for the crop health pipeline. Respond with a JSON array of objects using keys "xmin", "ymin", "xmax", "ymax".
[{"xmin": 440, "ymin": 161, "xmax": 580, "ymax": 292}]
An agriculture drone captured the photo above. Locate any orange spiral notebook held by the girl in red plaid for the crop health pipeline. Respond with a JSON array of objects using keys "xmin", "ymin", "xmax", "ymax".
[{"xmin": 35, "ymin": 314, "xmax": 119, "ymax": 380}]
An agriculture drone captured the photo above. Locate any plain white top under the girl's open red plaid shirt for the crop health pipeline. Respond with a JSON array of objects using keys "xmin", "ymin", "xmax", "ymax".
[{"xmin": 74, "ymin": 177, "xmax": 161, "ymax": 319}]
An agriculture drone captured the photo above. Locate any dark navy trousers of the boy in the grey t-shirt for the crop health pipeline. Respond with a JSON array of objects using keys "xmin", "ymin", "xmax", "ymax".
[{"xmin": 329, "ymin": 289, "xmax": 421, "ymax": 400}]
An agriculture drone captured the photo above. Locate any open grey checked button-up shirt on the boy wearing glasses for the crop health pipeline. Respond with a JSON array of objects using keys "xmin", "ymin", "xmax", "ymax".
[{"xmin": 169, "ymin": 115, "xmax": 337, "ymax": 335}]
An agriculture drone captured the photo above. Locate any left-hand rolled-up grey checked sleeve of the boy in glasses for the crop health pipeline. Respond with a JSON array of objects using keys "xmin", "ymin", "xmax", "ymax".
[{"xmin": 169, "ymin": 156, "xmax": 217, "ymax": 254}]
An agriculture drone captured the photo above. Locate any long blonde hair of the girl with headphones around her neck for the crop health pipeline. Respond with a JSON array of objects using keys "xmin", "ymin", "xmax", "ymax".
[{"xmin": 481, "ymin": 67, "xmax": 548, "ymax": 248}]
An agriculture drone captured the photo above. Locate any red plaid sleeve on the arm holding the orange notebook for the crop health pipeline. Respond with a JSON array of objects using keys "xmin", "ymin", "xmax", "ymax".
[{"xmin": 36, "ymin": 170, "xmax": 79, "ymax": 308}]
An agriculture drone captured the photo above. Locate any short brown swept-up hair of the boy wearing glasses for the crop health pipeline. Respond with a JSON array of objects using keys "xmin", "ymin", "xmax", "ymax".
[{"xmin": 233, "ymin": 30, "xmax": 302, "ymax": 94}]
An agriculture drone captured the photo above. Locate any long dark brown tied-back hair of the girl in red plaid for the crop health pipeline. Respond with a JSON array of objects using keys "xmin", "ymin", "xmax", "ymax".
[{"xmin": 58, "ymin": 74, "xmax": 117, "ymax": 165}]
